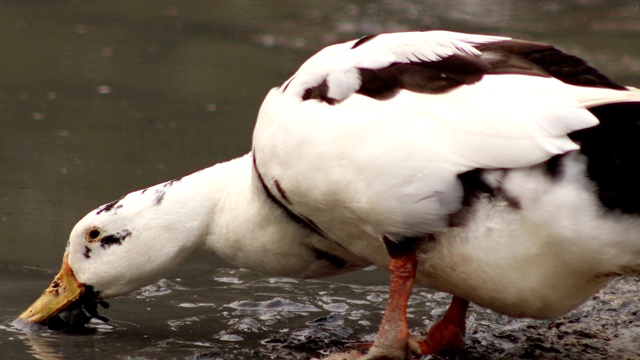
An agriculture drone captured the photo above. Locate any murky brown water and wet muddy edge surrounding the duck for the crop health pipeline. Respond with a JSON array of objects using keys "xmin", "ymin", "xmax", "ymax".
[{"xmin": 0, "ymin": 0, "xmax": 640, "ymax": 359}]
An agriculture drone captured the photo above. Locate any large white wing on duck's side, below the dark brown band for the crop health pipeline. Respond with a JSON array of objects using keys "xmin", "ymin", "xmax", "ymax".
[{"xmin": 254, "ymin": 75, "xmax": 597, "ymax": 237}]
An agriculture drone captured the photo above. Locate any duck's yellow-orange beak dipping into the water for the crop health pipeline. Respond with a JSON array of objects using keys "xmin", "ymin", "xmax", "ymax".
[{"xmin": 19, "ymin": 254, "xmax": 85, "ymax": 323}]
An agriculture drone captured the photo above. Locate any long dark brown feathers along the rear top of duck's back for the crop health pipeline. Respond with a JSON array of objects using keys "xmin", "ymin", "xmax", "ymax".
[{"xmin": 476, "ymin": 40, "xmax": 625, "ymax": 90}]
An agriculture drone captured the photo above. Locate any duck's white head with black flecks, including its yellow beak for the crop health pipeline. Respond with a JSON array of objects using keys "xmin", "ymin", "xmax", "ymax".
[{"xmin": 19, "ymin": 174, "xmax": 210, "ymax": 327}]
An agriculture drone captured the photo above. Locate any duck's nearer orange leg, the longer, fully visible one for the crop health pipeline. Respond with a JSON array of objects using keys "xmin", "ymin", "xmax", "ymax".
[{"xmin": 365, "ymin": 238, "xmax": 418, "ymax": 359}]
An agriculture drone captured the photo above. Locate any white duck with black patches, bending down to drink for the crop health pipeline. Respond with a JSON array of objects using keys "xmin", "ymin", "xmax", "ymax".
[{"xmin": 20, "ymin": 31, "xmax": 640, "ymax": 359}]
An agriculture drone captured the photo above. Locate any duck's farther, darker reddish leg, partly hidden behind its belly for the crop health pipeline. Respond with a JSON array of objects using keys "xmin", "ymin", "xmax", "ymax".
[{"xmin": 420, "ymin": 296, "xmax": 469, "ymax": 355}]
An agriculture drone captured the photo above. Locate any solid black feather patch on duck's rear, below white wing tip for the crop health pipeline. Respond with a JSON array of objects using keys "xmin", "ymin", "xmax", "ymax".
[{"xmin": 569, "ymin": 102, "xmax": 640, "ymax": 214}]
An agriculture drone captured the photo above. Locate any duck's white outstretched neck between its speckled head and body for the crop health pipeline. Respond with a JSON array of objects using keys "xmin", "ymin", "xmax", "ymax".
[{"xmin": 131, "ymin": 153, "xmax": 365, "ymax": 277}]
